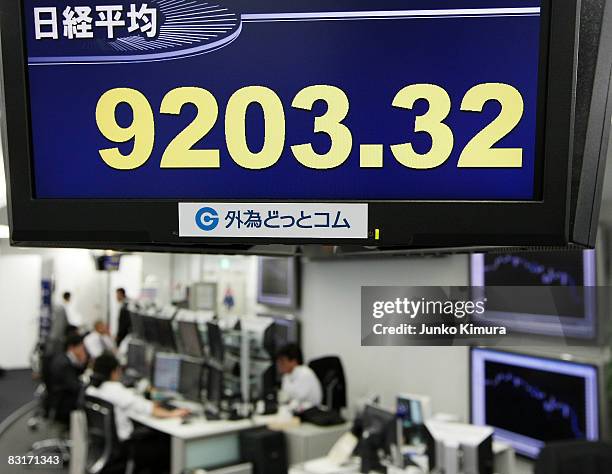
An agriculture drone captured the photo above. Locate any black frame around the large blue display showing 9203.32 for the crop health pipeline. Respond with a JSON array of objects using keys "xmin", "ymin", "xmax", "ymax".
[{"xmin": 0, "ymin": 0, "xmax": 580, "ymax": 253}]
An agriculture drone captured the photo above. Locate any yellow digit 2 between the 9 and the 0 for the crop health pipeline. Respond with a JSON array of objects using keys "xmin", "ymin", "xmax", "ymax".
[{"xmin": 160, "ymin": 87, "xmax": 220, "ymax": 168}]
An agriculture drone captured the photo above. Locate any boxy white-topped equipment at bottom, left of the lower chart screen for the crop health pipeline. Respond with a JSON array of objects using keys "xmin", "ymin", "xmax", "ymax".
[{"xmin": 425, "ymin": 421, "xmax": 493, "ymax": 474}]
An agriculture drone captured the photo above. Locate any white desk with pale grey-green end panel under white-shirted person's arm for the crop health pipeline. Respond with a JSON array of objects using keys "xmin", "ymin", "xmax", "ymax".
[{"xmin": 132, "ymin": 416, "xmax": 267, "ymax": 474}]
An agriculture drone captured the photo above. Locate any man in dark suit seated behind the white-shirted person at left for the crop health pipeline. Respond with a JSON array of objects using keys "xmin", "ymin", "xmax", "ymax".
[{"xmin": 45, "ymin": 334, "xmax": 87, "ymax": 425}]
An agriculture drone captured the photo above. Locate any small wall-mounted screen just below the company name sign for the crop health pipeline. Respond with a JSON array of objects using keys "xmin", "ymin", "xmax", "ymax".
[{"xmin": 257, "ymin": 257, "xmax": 299, "ymax": 308}]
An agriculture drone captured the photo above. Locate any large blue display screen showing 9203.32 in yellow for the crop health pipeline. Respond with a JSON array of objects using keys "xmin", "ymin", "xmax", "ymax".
[{"xmin": 24, "ymin": 0, "xmax": 544, "ymax": 201}]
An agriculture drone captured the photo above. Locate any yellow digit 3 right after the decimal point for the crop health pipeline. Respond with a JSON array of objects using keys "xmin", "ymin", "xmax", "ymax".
[{"xmin": 391, "ymin": 84, "xmax": 454, "ymax": 170}]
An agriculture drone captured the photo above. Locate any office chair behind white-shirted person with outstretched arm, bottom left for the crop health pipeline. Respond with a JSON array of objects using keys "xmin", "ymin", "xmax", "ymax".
[{"xmin": 84, "ymin": 395, "xmax": 135, "ymax": 474}]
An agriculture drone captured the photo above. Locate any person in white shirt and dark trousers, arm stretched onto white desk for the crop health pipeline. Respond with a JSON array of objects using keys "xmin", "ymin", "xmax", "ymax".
[{"xmin": 85, "ymin": 353, "xmax": 189, "ymax": 473}]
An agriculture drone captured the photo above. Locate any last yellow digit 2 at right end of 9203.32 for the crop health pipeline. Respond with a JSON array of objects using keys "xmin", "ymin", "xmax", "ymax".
[{"xmin": 458, "ymin": 83, "xmax": 525, "ymax": 168}]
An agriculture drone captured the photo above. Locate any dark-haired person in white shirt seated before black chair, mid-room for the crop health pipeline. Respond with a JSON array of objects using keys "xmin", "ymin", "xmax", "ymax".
[{"xmin": 276, "ymin": 344, "xmax": 323, "ymax": 412}]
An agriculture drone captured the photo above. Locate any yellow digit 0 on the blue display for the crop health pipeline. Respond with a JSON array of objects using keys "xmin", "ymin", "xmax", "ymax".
[{"xmin": 225, "ymin": 86, "xmax": 285, "ymax": 170}]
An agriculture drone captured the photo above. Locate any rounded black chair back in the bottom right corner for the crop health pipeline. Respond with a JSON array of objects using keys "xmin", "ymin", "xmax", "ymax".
[{"xmin": 535, "ymin": 441, "xmax": 612, "ymax": 474}]
